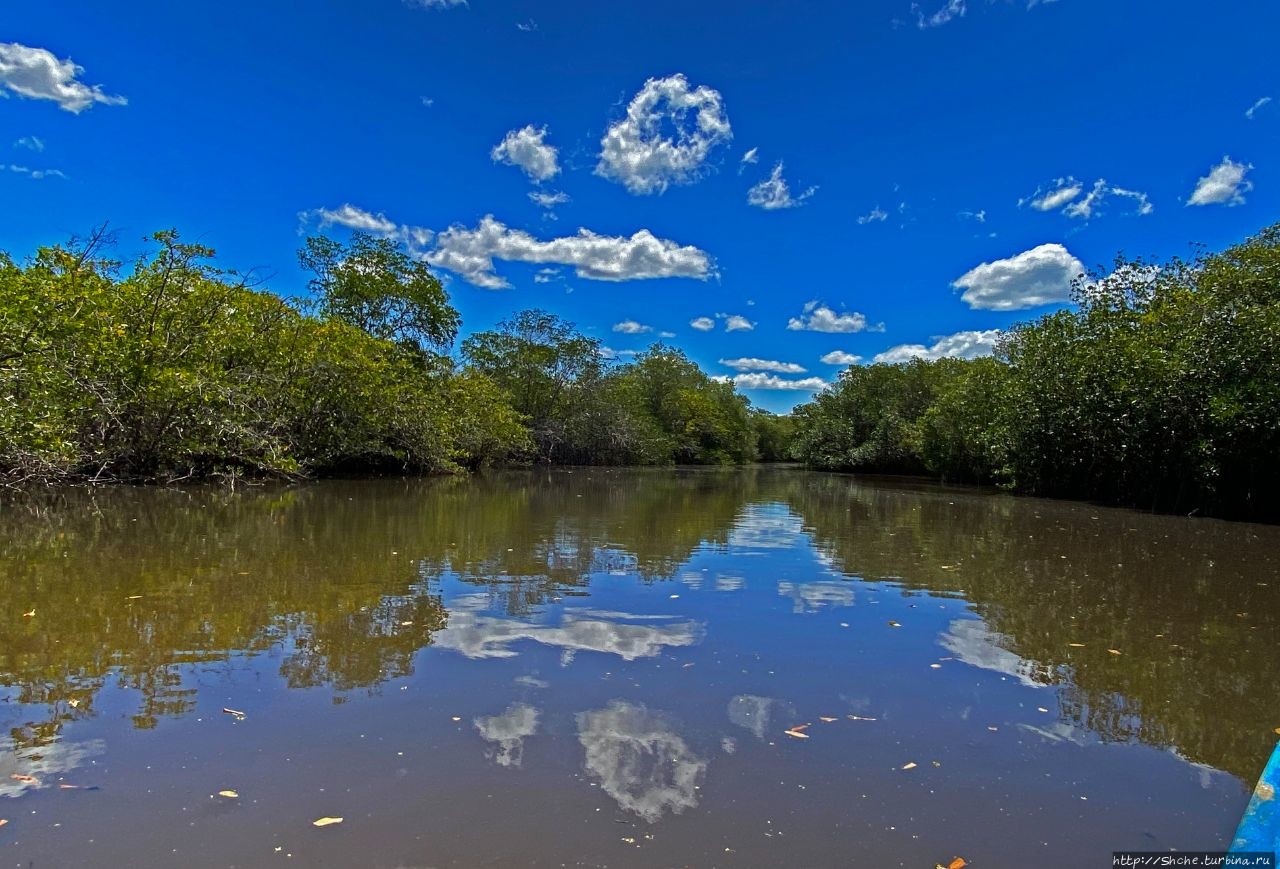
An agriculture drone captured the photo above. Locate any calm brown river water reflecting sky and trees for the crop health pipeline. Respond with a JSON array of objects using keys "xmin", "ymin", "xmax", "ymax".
[{"xmin": 0, "ymin": 470, "xmax": 1280, "ymax": 869}]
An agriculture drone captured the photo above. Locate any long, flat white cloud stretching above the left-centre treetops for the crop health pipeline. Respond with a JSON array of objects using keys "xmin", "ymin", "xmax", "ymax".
[{"xmin": 426, "ymin": 215, "xmax": 713, "ymax": 289}]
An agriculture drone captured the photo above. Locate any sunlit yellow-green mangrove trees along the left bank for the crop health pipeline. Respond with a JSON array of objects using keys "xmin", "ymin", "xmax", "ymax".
[{"xmin": 0, "ymin": 230, "xmax": 788, "ymax": 484}]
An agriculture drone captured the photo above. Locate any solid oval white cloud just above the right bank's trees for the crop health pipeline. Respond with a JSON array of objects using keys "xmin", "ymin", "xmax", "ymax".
[{"xmin": 951, "ymin": 244, "xmax": 1084, "ymax": 311}]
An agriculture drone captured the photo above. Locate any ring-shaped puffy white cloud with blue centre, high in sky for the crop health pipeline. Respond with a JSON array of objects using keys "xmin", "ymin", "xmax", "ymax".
[{"xmin": 595, "ymin": 74, "xmax": 733, "ymax": 195}]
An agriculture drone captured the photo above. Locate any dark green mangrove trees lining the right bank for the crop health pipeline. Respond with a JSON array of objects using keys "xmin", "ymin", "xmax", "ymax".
[{"xmin": 792, "ymin": 224, "xmax": 1280, "ymax": 521}]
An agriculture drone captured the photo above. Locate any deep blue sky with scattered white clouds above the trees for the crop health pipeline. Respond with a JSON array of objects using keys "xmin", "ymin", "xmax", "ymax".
[{"xmin": 0, "ymin": 0, "xmax": 1280, "ymax": 411}]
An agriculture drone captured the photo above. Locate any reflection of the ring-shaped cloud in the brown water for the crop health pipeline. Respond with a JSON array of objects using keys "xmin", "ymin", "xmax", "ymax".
[{"xmin": 577, "ymin": 700, "xmax": 707, "ymax": 824}]
